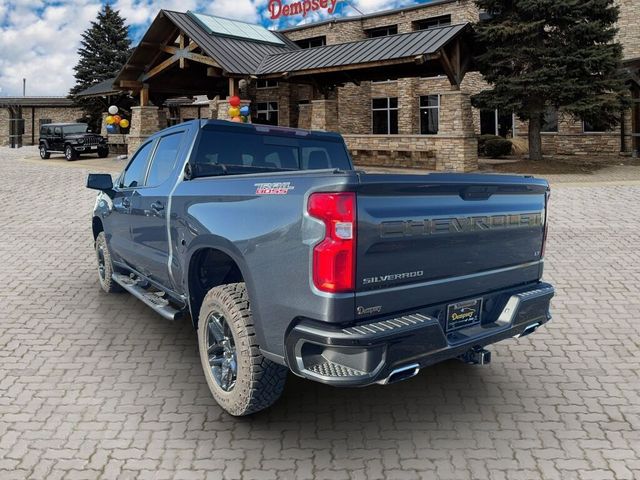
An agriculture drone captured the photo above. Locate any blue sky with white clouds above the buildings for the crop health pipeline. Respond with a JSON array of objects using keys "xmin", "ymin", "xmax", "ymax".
[{"xmin": 0, "ymin": 0, "xmax": 420, "ymax": 97}]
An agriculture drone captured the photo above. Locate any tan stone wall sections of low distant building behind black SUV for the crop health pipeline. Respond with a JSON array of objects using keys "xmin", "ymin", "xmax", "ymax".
[{"xmin": 0, "ymin": 107, "xmax": 83, "ymax": 145}]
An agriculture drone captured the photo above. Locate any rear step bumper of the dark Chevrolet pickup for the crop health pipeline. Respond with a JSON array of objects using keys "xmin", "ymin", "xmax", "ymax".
[{"xmin": 286, "ymin": 283, "xmax": 554, "ymax": 386}]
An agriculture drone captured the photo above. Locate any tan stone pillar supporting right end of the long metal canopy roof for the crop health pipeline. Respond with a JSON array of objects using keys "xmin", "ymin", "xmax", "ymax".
[{"xmin": 436, "ymin": 90, "xmax": 478, "ymax": 172}]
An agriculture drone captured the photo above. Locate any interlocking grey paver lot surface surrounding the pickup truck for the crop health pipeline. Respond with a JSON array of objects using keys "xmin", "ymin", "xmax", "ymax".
[{"xmin": 0, "ymin": 149, "xmax": 640, "ymax": 480}]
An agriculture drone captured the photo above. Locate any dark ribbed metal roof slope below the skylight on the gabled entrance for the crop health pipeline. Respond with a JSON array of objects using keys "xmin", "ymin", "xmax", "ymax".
[{"xmin": 162, "ymin": 10, "xmax": 299, "ymax": 75}]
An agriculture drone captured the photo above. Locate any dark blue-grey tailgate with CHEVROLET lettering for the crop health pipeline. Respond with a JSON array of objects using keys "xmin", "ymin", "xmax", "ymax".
[{"xmin": 355, "ymin": 174, "xmax": 548, "ymax": 318}]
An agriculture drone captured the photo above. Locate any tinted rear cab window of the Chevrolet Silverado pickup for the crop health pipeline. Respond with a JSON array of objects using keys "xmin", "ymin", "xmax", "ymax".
[{"xmin": 192, "ymin": 126, "xmax": 351, "ymax": 176}]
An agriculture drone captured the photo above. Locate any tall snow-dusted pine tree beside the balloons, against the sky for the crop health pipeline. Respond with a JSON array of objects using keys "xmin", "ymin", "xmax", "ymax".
[{"xmin": 69, "ymin": 4, "xmax": 131, "ymax": 131}]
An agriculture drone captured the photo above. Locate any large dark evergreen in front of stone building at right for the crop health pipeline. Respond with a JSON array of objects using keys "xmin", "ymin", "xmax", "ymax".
[{"xmin": 472, "ymin": 0, "xmax": 628, "ymax": 160}]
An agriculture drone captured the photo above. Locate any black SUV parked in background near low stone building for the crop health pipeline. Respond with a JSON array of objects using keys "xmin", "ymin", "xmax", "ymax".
[{"xmin": 39, "ymin": 123, "xmax": 109, "ymax": 160}]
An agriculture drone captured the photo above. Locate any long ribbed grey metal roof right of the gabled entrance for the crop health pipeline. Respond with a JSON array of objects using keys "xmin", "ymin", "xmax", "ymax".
[{"xmin": 256, "ymin": 23, "xmax": 469, "ymax": 75}]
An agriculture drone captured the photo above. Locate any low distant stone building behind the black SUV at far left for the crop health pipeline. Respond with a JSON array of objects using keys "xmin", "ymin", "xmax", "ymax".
[{"xmin": 0, "ymin": 97, "xmax": 84, "ymax": 146}]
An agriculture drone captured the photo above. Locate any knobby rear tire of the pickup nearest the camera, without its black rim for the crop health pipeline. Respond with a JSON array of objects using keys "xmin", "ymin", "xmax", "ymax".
[{"xmin": 198, "ymin": 283, "xmax": 288, "ymax": 416}]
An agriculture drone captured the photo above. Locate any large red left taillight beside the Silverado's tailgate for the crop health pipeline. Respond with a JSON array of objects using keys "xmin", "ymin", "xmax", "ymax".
[{"xmin": 307, "ymin": 192, "xmax": 356, "ymax": 293}]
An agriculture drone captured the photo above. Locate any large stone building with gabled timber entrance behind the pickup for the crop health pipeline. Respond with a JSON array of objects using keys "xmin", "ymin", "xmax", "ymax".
[{"xmin": 35, "ymin": 0, "xmax": 640, "ymax": 171}]
